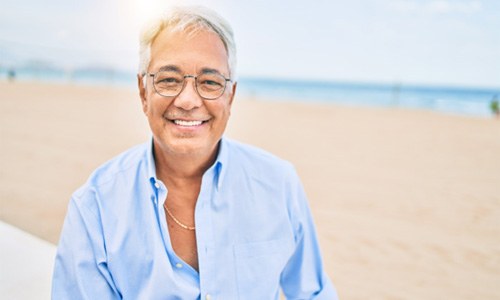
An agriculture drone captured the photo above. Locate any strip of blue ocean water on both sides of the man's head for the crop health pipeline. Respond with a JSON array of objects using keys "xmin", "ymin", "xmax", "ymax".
[{"xmin": 0, "ymin": 68, "xmax": 500, "ymax": 117}]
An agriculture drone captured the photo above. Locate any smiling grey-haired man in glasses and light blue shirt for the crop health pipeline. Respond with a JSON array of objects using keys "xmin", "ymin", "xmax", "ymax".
[{"xmin": 52, "ymin": 8, "xmax": 337, "ymax": 300}]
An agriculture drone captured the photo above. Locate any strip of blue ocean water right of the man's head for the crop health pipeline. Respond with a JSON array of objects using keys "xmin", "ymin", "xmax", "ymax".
[{"xmin": 238, "ymin": 78, "xmax": 500, "ymax": 117}]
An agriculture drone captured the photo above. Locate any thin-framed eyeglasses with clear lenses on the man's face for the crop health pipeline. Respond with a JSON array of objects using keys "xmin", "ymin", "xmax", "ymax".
[{"xmin": 147, "ymin": 71, "xmax": 231, "ymax": 100}]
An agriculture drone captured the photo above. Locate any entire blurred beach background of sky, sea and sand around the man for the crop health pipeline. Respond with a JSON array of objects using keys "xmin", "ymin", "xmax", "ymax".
[{"xmin": 0, "ymin": 0, "xmax": 500, "ymax": 299}]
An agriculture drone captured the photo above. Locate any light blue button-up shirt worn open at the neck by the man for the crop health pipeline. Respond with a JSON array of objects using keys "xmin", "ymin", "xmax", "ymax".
[{"xmin": 52, "ymin": 138, "xmax": 337, "ymax": 300}]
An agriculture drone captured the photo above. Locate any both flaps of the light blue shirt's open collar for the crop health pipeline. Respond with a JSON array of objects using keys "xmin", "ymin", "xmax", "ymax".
[{"xmin": 147, "ymin": 137, "xmax": 229, "ymax": 189}]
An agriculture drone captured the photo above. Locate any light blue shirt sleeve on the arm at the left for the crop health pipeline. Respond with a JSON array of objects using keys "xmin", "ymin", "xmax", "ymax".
[{"xmin": 52, "ymin": 193, "xmax": 121, "ymax": 300}]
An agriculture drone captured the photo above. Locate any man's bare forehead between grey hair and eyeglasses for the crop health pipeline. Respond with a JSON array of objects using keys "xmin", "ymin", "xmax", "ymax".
[{"xmin": 149, "ymin": 29, "xmax": 229, "ymax": 75}]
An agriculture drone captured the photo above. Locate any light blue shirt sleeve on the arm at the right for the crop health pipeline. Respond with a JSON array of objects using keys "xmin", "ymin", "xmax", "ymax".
[{"xmin": 280, "ymin": 166, "xmax": 338, "ymax": 300}]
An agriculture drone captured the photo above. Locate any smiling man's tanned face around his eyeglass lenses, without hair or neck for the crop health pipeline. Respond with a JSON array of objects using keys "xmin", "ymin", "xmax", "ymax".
[{"xmin": 139, "ymin": 30, "xmax": 236, "ymax": 156}]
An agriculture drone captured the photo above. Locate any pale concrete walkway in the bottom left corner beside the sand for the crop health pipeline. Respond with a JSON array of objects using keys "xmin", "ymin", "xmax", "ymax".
[{"xmin": 0, "ymin": 221, "xmax": 56, "ymax": 300}]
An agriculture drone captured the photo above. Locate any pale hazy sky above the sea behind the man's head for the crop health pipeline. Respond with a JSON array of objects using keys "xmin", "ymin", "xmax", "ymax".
[{"xmin": 0, "ymin": 0, "xmax": 500, "ymax": 88}]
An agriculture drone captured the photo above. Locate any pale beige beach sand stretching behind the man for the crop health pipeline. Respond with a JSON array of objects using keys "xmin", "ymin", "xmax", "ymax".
[{"xmin": 0, "ymin": 82, "xmax": 500, "ymax": 299}]
